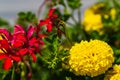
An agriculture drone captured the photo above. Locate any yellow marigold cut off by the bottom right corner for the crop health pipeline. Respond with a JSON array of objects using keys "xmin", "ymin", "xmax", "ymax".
[{"xmin": 104, "ymin": 65, "xmax": 120, "ymax": 80}]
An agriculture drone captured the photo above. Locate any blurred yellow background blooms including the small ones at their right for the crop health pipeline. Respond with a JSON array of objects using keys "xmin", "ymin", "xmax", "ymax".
[{"xmin": 82, "ymin": 3, "xmax": 116, "ymax": 34}]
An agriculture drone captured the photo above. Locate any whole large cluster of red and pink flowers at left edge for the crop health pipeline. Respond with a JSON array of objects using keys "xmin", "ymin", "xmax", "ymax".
[{"xmin": 0, "ymin": 25, "xmax": 44, "ymax": 70}]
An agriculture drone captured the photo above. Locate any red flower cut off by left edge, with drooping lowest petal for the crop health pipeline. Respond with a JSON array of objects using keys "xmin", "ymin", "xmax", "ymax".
[{"xmin": 0, "ymin": 39, "xmax": 21, "ymax": 70}]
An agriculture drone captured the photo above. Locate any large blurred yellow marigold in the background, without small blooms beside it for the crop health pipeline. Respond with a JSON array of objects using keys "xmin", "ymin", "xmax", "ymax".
[{"xmin": 82, "ymin": 4, "xmax": 103, "ymax": 33}]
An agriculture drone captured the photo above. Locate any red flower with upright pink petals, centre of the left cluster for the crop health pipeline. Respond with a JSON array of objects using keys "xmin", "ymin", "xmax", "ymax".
[{"xmin": 13, "ymin": 25, "xmax": 39, "ymax": 62}]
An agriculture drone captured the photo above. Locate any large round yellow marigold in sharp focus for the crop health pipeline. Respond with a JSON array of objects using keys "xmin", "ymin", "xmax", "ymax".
[{"xmin": 69, "ymin": 40, "xmax": 114, "ymax": 77}]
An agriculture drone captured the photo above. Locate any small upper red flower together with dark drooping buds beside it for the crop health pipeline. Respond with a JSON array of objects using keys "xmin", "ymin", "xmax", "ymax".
[{"xmin": 39, "ymin": 8, "xmax": 64, "ymax": 38}]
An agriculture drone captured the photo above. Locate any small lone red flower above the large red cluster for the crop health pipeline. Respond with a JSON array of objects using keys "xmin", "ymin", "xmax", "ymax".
[{"xmin": 39, "ymin": 9, "xmax": 57, "ymax": 32}]
